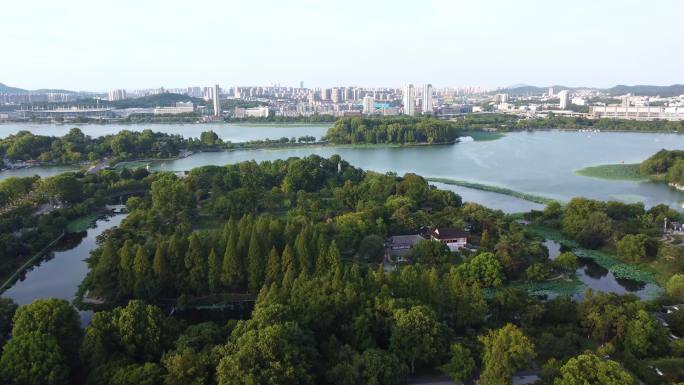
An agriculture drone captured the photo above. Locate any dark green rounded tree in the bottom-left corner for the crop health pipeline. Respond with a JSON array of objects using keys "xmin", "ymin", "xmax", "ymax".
[{"xmin": 0, "ymin": 331, "xmax": 69, "ymax": 385}]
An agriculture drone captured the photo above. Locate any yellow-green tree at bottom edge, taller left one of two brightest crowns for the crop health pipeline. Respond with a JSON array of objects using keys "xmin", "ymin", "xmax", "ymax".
[{"xmin": 477, "ymin": 324, "xmax": 535, "ymax": 385}]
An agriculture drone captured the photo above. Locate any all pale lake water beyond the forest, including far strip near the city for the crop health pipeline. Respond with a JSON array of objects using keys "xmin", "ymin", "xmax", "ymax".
[{"xmin": 0, "ymin": 123, "xmax": 684, "ymax": 212}]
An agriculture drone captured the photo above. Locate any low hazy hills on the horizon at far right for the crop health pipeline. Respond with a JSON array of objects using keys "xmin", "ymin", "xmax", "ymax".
[{"xmin": 497, "ymin": 84, "xmax": 684, "ymax": 97}]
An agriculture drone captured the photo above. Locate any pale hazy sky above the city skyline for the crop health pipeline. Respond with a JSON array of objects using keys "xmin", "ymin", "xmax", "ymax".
[{"xmin": 0, "ymin": 0, "xmax": 684, "ymax": 91}]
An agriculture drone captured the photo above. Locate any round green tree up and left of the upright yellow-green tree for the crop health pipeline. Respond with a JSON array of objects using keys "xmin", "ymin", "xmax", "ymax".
[{"xmin": 390, "ymin": 305, "xmax": 443, "ymax": 373}]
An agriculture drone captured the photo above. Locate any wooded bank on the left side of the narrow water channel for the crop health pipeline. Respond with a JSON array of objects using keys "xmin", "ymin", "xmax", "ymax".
[{"xmin": 0, "ymin": 169, "xmax": 148, "ymax": 290}]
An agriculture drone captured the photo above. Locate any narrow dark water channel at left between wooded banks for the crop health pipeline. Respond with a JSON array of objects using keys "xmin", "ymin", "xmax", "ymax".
[{"xmin": 2, "ymin": 210, "xmax": 126, "ymax": 325}]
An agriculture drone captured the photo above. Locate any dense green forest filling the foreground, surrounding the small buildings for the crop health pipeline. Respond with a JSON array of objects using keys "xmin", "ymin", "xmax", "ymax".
[{"xmin": 0, "ymin": 155, "xmax": 684, "ymax": 385}]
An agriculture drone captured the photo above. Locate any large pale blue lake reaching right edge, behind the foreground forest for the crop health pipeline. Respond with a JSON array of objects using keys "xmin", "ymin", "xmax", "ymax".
[{"xmin": 151, "ymin": 130, "xmax": 684, "ymax": 210}]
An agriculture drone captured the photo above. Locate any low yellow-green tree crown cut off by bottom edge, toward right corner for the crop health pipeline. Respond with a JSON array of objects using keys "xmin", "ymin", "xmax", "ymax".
[{"xmin": 553, "ymin": 353, "xmax": 634, "ymax": 385}]
